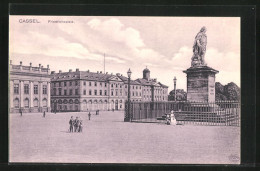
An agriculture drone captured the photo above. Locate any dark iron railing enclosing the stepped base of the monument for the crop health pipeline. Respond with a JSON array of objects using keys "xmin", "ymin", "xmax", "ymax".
[{"xmin": 125, "ymin": 101, "xmax": 240, "ymax": 126}]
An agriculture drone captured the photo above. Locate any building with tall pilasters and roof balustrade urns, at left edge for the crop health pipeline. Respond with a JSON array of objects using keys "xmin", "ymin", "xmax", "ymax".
[{"xmin": 9, "ymin": 61, "xmax": 51, "ymax": 113}]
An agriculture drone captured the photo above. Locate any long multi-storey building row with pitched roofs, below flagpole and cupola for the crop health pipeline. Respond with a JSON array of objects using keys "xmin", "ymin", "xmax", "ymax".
[{"xmin": 51, "ymin": 69, "xmax": 168, "ymax": 112}]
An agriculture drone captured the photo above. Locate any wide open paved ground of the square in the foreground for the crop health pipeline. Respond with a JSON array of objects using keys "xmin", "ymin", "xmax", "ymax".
[{"xmin": 9, "ymin": 111, "xmax": 240, "ymax": 164}]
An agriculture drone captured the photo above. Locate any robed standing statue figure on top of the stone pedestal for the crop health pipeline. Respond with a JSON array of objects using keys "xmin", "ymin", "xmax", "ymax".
[{"xmin": 191, "ymin": 26, "xmax": 207, "ymax": 67}]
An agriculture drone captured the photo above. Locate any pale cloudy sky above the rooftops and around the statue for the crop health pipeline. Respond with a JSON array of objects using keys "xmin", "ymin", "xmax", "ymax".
[{"xmin": 9, "ymin": 15, "xmax": 240, "ymax": 91}]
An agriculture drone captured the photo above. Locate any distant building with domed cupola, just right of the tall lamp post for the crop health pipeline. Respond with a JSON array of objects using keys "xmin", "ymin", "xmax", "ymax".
[{"xmin": 136, "ymin": 68, "xmax": 168, "ymax": 101}]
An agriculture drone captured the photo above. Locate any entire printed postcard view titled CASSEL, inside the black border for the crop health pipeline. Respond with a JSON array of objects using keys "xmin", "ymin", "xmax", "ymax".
[{"xmin": 9, "ymin": 15, "xmax": 241, "ymax": 164}]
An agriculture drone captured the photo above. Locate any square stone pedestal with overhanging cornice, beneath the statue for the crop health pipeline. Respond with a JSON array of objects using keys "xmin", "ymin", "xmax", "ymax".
[{"xmin": 183, "ymin": 66, "xmax": 219, "ymax": 102}]
